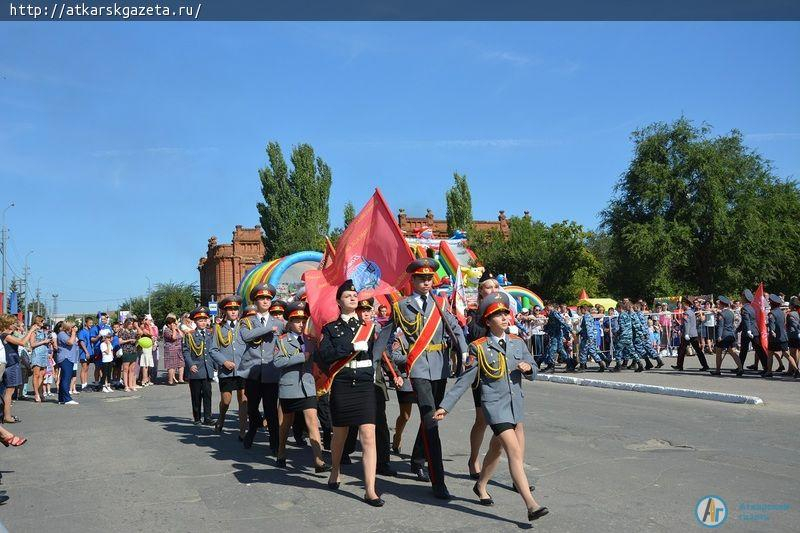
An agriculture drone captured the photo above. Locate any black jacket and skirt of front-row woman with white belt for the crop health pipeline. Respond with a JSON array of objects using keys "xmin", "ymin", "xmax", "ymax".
[{"xmin": 319, "ymin": 317, "xmax": 376, "ymax": 427}]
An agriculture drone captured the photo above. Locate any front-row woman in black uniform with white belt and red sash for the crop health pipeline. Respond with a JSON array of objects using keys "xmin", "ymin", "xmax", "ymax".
[{"xmin": 319, "ymin": 279, "xmax": 385, "ymax": 507}]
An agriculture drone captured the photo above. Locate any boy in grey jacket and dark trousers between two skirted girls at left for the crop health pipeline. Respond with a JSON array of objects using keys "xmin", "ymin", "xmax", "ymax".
[{"xmin": 239, "ymin": 283, "xmax": 284, "ymax": 453}]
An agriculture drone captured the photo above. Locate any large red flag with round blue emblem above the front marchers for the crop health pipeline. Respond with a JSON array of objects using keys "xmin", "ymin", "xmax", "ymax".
[{"xmin": 303, "ymin": 189, "xmax": 414, "ymax": 329}]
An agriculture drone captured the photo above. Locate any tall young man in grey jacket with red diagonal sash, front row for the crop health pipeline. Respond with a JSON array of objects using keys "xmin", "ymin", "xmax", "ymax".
[{"xmin": 381, "ymin": 257, "xmax": 468, "ymax": 500}]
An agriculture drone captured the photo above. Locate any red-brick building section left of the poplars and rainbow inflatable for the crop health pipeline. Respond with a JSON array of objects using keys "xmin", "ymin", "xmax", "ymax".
[{"xmin": 197, "ymin": 226, "xmax": 264, "ymax": 305}]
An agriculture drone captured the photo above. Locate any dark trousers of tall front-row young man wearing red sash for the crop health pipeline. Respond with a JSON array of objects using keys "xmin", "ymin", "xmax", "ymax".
[{"xmin": 411, "ymin": 378, "xmax": 447, "ymax": 487}]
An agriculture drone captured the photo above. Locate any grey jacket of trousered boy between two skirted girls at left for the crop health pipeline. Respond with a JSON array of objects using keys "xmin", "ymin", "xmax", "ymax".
[{"xmin": 237, "ymin": 315, "xmax": 283, "ymax": 383}]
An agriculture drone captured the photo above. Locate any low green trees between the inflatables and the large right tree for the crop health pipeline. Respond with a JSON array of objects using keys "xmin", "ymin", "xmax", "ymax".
[{"xmin": 470, "ymin": 217, "xmax": 601, "ymax": 304}]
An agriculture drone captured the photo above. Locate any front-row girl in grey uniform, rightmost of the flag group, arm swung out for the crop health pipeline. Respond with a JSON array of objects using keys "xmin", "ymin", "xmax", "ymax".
[{"xmin": 434, "ymin": 293, "xmax": 549, "ymax": 521}]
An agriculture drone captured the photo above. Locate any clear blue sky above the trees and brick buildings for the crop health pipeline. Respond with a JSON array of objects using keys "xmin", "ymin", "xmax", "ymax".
[{"xmin": 0, "ymin": 23, "xmax": 800, "ymax": 312}]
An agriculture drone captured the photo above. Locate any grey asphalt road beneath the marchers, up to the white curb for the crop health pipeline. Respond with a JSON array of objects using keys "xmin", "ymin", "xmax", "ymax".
[{"xmin": 0, "ymin": 374, "xmax": 800, "ymax": 532}]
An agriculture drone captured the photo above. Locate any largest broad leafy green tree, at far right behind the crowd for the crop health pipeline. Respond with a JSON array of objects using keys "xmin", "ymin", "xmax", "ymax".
[{"xmin": 601, "ymin": 118, "xmax": 800, "ymax": 298}]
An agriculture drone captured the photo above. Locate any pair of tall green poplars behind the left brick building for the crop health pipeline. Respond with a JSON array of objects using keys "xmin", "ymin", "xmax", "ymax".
[{"xmin": 257, "ymin": 142, "xmax": 331, "ymax": 260}]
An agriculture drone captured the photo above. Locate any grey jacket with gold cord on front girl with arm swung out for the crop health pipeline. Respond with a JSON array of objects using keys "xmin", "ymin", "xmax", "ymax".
[{"xmin": 440, "ymin": 335, "xmax": 536, "ymax": 424}]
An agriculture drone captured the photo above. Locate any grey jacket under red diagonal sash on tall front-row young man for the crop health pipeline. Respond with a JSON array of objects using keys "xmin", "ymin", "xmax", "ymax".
[{"xmin": 379, "ymin": 296, "xmax": 469, "ymax": 381}]
